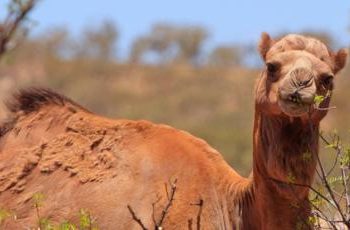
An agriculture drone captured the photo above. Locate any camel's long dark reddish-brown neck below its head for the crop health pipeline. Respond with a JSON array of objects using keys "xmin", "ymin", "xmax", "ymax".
[{"xmin": 242, "ymin": 113, "xmax": 319, "ymax": 229}]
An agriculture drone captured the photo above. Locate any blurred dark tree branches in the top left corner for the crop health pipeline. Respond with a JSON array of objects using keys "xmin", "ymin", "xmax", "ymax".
[{"xmin": 0, "ymin": 0, "xmax": 38, "ymax": 57}]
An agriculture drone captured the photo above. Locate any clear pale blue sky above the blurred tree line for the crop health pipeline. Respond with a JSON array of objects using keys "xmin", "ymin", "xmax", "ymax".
[{"xmin": 21, "ymin": 0, "xmax": 350, "ymax": 53}]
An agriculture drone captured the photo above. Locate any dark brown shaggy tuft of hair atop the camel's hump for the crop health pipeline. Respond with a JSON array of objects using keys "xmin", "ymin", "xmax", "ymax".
[{"xmin": 6, "ymin": 87, "xmax": 87, "ymax": 114}]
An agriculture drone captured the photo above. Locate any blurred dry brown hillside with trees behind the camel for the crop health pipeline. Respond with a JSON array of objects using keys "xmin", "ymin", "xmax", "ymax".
[{"xmin": 0, "ymin": 16, "xmax": 350, "ymax": 175}]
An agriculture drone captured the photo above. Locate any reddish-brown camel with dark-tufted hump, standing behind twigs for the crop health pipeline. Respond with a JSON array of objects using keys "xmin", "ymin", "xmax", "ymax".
[{"xmin": 0, "ymin": 33, "xmax": 347, "ymax": 230}]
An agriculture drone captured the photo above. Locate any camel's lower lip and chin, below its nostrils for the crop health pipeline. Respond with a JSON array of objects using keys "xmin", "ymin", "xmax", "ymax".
[{"xmin": 278, "ymin": 98, "xmax": 310, "ymax": 117}]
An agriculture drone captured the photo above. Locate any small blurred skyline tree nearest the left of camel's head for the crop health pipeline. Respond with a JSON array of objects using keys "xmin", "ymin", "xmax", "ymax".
[{"xmin": 208, "ymin": 45, "xmax": 242, "ymax": 67}]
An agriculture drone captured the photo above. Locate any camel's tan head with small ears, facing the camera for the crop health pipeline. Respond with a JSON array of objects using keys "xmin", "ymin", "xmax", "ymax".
[{"xmin": 256, "ymin": 33, "xmax": 347, "ymax": 121}]
